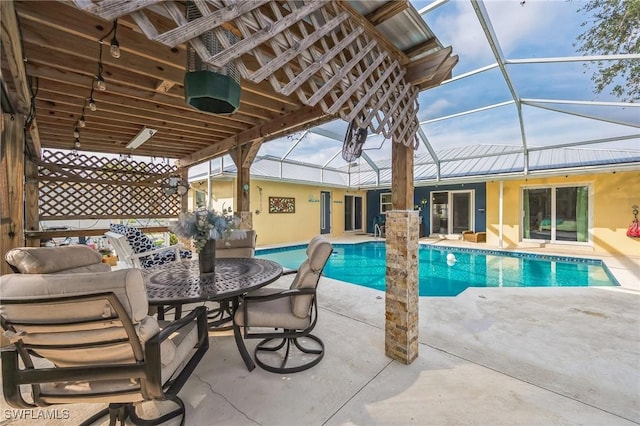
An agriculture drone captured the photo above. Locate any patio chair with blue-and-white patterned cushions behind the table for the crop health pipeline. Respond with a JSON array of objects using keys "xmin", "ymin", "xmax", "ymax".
[{"xmin": 105, "ymin": 223, "xmax": 193, "ymax": 268}]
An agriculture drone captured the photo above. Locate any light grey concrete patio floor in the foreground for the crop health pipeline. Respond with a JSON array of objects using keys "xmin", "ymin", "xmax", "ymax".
[{"xmin": 0, "ymin": 238, "xmax": 640, "ymax": 426}]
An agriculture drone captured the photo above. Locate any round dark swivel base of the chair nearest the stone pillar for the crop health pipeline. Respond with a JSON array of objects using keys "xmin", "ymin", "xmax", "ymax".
[{"xmin": 254, "ymin": 334, "xmax": 324, "ymax": 374}]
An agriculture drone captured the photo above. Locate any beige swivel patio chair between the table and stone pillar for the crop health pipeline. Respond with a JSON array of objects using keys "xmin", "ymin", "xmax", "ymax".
[{"xmin": 234, "ymin": 236, "xmax": 333, "ymax": 374}]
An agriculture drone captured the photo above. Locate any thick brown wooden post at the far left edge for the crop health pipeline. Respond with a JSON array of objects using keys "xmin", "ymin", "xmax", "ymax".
[{"xmin": 0, "ymin": 114, "xmax": 25, "ymax": 275}]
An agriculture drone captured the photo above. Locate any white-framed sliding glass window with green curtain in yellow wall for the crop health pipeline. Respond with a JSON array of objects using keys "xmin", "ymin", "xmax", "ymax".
[{"xmin": 522, "ymin": 185, "xmax": 591, "ymax": 243}]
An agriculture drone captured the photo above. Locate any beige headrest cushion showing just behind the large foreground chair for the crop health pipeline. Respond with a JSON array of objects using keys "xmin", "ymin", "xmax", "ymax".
[{"xmin": 5, "ymin": 245, "xmax": 111, "ymax": 274}]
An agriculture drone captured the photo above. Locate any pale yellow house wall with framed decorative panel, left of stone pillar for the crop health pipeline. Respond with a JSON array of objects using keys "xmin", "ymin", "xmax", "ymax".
[{"xmin": 198, "ymin": 179, "xmax": 366, "ymax": 246}]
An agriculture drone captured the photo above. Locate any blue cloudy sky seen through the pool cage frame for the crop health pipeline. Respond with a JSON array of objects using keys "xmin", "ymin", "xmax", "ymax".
[{"xmin": 258, "ymin": 0, "xmax": 640, "ymax": 167}]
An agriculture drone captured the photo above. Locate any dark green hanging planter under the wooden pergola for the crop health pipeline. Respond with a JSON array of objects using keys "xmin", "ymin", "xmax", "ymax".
[{"xmin": 184, "ymin": 2, "xmax": 241, "ymax": 114}]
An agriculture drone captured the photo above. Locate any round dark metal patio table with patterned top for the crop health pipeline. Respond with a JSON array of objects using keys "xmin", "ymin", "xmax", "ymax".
[{"xmin": 142, "ymin": 257, "xmax": 282, "ymax": 371}]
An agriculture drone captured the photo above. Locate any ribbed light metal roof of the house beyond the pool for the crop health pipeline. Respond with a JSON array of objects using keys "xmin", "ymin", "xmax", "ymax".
[{"xmin": 190, "ymin": 145, "xmax": 640, "ymax": 188}]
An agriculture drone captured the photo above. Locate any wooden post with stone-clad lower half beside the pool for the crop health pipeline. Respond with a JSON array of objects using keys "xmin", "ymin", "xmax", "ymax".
[{"xmin": 385, "ymin": 141, "xmax": 420, "ymax": 364}]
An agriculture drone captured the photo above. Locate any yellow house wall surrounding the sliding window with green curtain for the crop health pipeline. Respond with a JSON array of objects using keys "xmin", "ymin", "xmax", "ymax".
[{"xmin": 487, "ymin": 171, "xmax": 640, "ymax": 256}]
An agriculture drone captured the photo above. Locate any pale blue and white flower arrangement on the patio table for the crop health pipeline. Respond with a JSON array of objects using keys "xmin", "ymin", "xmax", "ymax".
[{"xmin": 170, "ymin": 207, "xmax": 246, "ymax": 253}]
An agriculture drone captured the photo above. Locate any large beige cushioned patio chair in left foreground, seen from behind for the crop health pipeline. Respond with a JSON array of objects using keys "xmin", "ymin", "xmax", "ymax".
[{"xmin": 0, "ymin": 269, "xmax": 209, "ymax": 425}]
